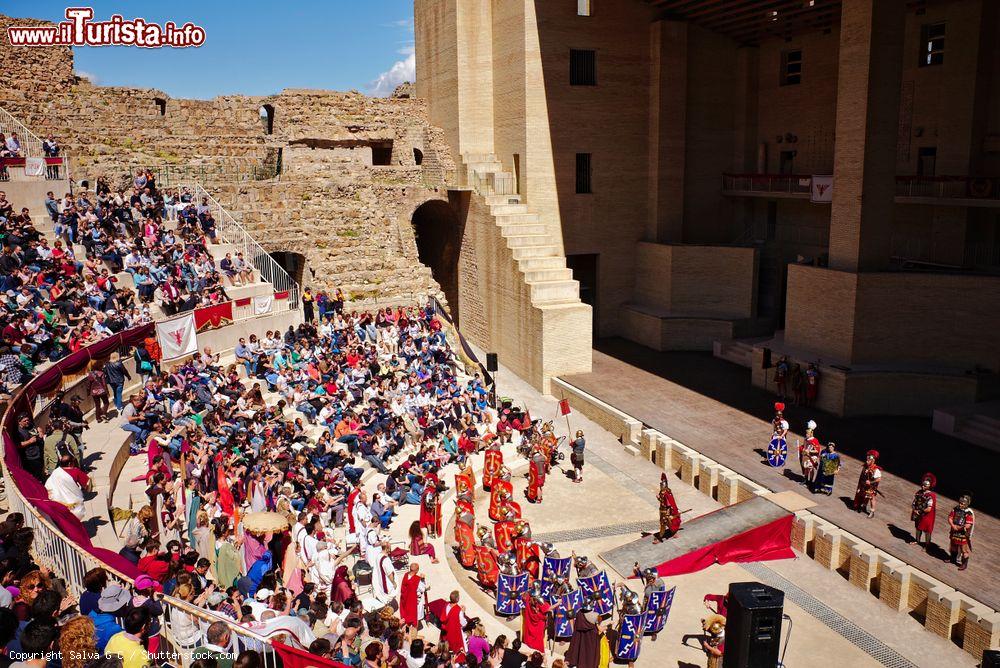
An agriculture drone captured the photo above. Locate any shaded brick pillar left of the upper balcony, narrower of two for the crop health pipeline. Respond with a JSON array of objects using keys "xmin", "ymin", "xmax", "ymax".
[{"xmin": 646, "ymin": 21, "xmax": 687, "ymax": 243}]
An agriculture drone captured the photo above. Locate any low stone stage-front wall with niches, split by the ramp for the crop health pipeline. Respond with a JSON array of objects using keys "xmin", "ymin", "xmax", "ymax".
[{"xmin": 552, "ymin": 379, "xmax": 1000, "ymax": 659}]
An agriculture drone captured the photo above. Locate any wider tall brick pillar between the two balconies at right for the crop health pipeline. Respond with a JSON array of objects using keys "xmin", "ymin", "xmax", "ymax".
[{"xmin": 830, "ymin": 0, "xmax": 905, "ymax": 272}]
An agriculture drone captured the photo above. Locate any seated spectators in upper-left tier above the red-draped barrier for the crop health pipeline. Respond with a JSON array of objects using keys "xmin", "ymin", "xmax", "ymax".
[{"xmin": 0, "ymin": 172, "xmax": 262, "ymax": 392}]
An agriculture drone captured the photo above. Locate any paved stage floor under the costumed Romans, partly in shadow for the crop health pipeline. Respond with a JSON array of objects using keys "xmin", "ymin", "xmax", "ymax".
[{"xmin": 563, "ymin": 348, "xmax": 1000, "ymax": 609}]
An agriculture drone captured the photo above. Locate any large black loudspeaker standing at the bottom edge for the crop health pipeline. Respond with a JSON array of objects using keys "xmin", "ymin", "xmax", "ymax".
[{"xmin": 722, "ymin": 582, "xmax": 785, "ymax": 668}]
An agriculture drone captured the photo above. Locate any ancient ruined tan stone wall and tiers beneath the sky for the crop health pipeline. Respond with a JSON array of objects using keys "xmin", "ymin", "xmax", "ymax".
[{"xmin": 0, "ymin": 17, "xmax": 455, "ymax": 306}]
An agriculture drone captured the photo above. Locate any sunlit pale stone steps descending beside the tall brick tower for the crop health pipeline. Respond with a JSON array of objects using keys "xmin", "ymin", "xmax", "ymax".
[{"xmin": 464, "ymin": 153, "xmax": 580, "ymax": 306}]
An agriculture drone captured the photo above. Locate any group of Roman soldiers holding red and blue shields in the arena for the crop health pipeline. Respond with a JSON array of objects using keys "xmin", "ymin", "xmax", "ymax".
[{"xmin": 455, "ymin": 425, "xmax": 679, "ymax": 668}]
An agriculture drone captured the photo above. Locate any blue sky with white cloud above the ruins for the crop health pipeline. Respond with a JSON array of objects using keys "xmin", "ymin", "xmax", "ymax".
[{"xmin": 0, "ymin": 0, "xmax": 413, "ymax": 99}]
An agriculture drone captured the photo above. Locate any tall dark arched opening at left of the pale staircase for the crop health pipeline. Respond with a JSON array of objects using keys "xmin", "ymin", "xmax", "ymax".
[{"xmin": 412, "ymin": 200, "xmax": 465, "ymax": 321}]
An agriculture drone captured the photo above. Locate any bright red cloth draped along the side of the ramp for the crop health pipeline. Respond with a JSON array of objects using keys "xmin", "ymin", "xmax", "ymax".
[{"xmin": 656, "ymin": 514, "xmax": 795, "ymax": 576}]
